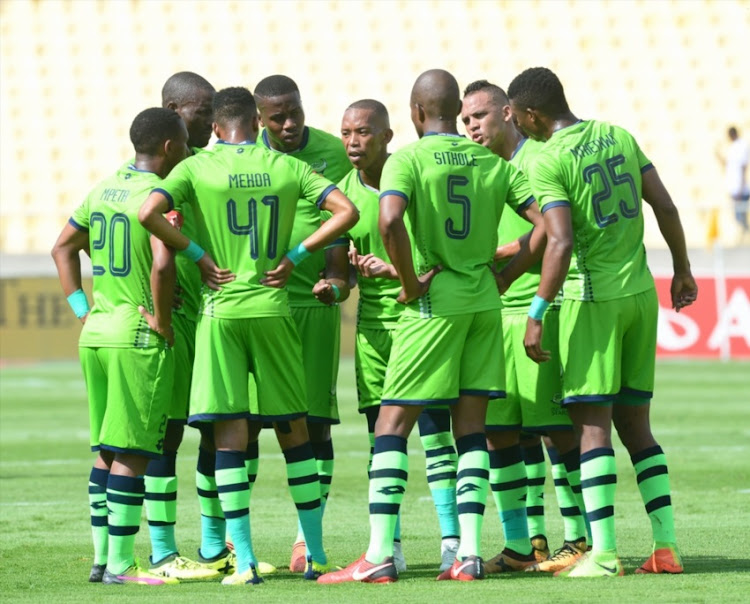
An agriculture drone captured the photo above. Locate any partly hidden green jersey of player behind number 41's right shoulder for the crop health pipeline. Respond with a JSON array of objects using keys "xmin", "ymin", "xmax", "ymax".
[{"xmin": 260, "ymin": 126, "xmax": 352, "ymax": 307}]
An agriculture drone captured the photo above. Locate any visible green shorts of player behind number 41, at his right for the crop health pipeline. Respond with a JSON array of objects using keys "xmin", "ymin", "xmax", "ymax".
[{"xmin": 290, "ymin": 304, "xmax": 341, "ymax": 424}]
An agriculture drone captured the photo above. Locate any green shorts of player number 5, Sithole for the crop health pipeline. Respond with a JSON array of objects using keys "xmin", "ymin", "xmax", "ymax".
[{"xmin": 382, "ymin": 309, "xmax": 505, "ymax": 405}]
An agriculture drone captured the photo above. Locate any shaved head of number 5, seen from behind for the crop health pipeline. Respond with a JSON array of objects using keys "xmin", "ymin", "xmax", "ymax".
[{"xmin": 411, "ymin": 69, "xmax": 461, "ymax": 136}]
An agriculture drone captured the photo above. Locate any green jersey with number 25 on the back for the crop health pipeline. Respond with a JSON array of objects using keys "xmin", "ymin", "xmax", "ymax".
[{"xmin": 529, "ymin": 120, "xmax": 654, "ymax": 301}]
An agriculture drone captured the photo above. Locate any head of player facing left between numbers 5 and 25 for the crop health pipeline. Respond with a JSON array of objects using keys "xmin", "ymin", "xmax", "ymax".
[{"xmin": 461, "ymin": 80, "xmax": 517, "ymax": 159}]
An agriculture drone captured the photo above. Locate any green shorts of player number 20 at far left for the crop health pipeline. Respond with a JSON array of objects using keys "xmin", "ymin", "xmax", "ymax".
[{"xmin": 79, "ymin": 347, "xmax": 174, "ymax": 458}]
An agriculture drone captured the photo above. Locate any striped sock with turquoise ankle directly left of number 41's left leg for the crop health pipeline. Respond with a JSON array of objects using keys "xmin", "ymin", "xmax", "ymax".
[{"xmin": 195, "ymin": 447, "xmax": 227, "ymax": 558}]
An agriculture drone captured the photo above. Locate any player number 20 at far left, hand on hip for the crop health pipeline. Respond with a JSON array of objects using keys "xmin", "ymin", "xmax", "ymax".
[{"xmin": 52, "ymin": 108, "xmax": 188, "ymax": 585}]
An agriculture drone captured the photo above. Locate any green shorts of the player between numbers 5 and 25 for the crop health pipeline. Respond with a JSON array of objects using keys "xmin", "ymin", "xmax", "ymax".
[{"xmin": 486, "ymin": 307, "xmax": 572, "ymax": 434}]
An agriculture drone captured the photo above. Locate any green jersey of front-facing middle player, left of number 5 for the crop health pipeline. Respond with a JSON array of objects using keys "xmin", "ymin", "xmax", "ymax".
[{"xmin": 339, "ymin": 169, "xmax": 403, "ymax": 329}]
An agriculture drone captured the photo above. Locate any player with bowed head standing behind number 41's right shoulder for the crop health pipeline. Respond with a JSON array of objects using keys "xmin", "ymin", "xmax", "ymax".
[{"xmin": 251, "ymin": 75, "xmax": 351, "ymax": 572}]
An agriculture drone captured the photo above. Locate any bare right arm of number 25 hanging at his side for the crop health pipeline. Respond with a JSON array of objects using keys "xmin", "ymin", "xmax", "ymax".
[{"xmin": 642, "ymin": 168, "xmax": 698, "ymax": 312}]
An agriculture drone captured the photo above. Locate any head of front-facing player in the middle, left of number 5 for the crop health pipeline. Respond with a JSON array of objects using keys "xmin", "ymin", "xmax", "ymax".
[{"xmin": 341, "ymin": 99, "xmax": 393, "ymax": 170}]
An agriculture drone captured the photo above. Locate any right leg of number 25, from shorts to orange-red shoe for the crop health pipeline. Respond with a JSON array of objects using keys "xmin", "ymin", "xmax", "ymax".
[{"xmin": 613, "ymin": 290, "xmax": 683, "ymax": 573}]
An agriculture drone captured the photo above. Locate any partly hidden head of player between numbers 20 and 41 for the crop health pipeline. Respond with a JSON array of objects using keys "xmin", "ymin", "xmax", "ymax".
[{"xmin": 161, "ymin": 71, "xmax": 216, "ymax": 147}]
